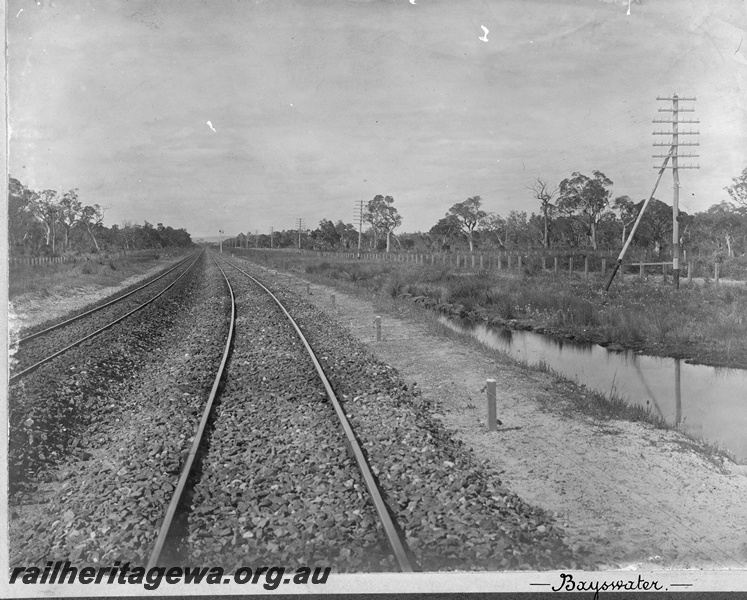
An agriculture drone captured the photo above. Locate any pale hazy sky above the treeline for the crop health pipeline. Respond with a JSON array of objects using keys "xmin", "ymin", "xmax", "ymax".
[{"xmin": 7, "ymin": 0, "xmax": 747, "ymax": 237}]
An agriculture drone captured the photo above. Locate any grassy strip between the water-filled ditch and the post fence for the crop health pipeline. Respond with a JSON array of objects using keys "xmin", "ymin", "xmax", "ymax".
[{"xmin": 240, "ymin": 252, "xmax": 747, "ymax": 368}]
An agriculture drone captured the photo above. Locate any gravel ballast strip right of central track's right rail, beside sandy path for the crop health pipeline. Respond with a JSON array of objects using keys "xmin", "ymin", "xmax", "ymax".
[{"xmin": 215, "ymin": 255, "xmax": 583, "ymax": 570}]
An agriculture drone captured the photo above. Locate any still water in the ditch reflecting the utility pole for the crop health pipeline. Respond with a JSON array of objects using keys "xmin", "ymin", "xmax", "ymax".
[{"xmin": 440, "ymin": 317, "xmax": 747, "ymax": 460}]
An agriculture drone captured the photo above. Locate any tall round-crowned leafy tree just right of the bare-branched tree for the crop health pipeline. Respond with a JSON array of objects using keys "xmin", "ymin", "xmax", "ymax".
[{"xmin": 557, "ymin": 171, "xmax": 612, "ymax": 250}]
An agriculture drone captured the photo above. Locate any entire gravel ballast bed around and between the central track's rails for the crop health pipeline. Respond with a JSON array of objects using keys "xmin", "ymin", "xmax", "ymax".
[{"xmin": 11, "ymin": 252, "xmax": 585, "ymax": 572}]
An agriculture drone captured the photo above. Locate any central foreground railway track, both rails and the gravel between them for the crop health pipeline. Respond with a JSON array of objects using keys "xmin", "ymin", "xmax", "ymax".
[{"xmin": 148, "ymin": 253, "xmax": 413, "ymax": 572}]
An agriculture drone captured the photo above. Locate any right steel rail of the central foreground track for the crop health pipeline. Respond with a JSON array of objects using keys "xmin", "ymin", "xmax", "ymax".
[{"xmin": 219, "ymin": 259, "xmax": 413, "ymax": 573}]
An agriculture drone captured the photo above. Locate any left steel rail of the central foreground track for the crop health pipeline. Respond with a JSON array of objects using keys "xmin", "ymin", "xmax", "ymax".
[{"xmin": 147, "ymin": 258, "xmax": 236, "ymax": 570}]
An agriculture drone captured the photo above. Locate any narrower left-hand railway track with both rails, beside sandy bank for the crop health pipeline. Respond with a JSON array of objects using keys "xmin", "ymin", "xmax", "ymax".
[{"xmin": 9, "ymin": 254, "xmax": 199, "ymax": 385}]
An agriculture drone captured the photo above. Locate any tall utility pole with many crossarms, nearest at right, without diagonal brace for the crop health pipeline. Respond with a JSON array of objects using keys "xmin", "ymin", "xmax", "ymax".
[{"xmin": 653, "ymin": 94, "xmax": 700, "ymax": 289}]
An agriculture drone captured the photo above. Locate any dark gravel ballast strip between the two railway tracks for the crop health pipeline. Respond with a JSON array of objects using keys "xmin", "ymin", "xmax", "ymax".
[{"xmin": 10, "ymin": 253, "xmax": 229, "ymax": 565}]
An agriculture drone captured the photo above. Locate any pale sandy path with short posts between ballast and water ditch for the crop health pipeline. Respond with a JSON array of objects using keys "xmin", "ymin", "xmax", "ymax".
[{"xmin": 270, "ymin": 264, "xmax": 747, "ymax": 570}]
